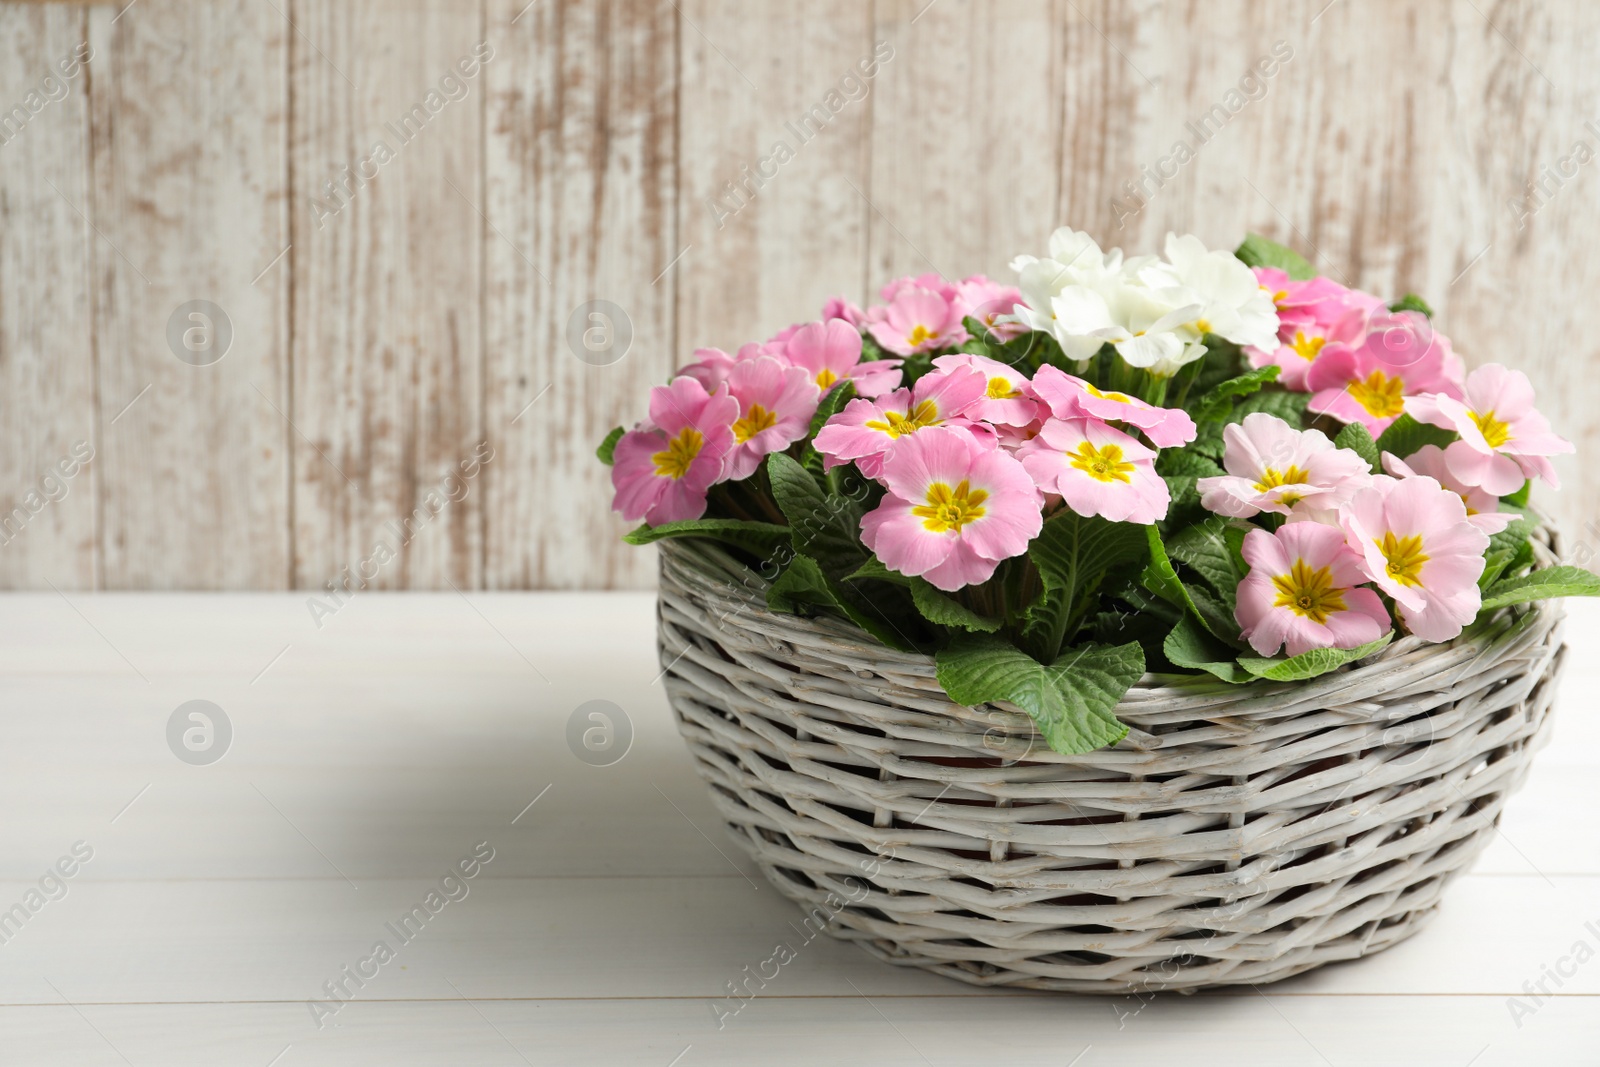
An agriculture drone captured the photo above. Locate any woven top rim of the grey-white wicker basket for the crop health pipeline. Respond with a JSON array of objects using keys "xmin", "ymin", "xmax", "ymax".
[{"xmin": 658, "ymin": 517, "xmax": 1565, "ymax": 718}]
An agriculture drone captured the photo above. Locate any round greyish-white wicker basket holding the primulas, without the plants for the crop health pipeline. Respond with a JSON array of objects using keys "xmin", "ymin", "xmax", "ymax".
[{"xmin": 659, "ymin": 541, "xmax": 1563, "ymax": 993}]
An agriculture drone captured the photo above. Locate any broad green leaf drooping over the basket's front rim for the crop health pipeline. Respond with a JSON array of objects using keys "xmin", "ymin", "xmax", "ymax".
[{"xmin": 936, "ymin": 633, "xmax": 1144, "ymax": 755}]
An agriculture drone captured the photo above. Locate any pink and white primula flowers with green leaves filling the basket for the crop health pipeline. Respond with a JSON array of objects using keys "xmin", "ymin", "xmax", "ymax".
[{"xmin": 598, "ymin": 229, "xmax": 1600, "ymax": 753}]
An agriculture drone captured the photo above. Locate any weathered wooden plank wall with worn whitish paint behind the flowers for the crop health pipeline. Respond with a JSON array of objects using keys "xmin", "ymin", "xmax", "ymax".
[{"xmin": 0, "ymin": 0, "xmax": 1600, "ymax": 592}]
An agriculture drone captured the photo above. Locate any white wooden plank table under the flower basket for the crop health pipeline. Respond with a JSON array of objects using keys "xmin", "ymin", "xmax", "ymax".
[{"xmin": 0, "ymin": 593, "xmax": 1600, "ymax": 1067}]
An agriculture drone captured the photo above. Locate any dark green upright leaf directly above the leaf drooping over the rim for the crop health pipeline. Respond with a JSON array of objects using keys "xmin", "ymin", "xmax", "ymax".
[{"xmin": 1024, "ymin": 509, "xmax": 1146, "ymax": 659}]
